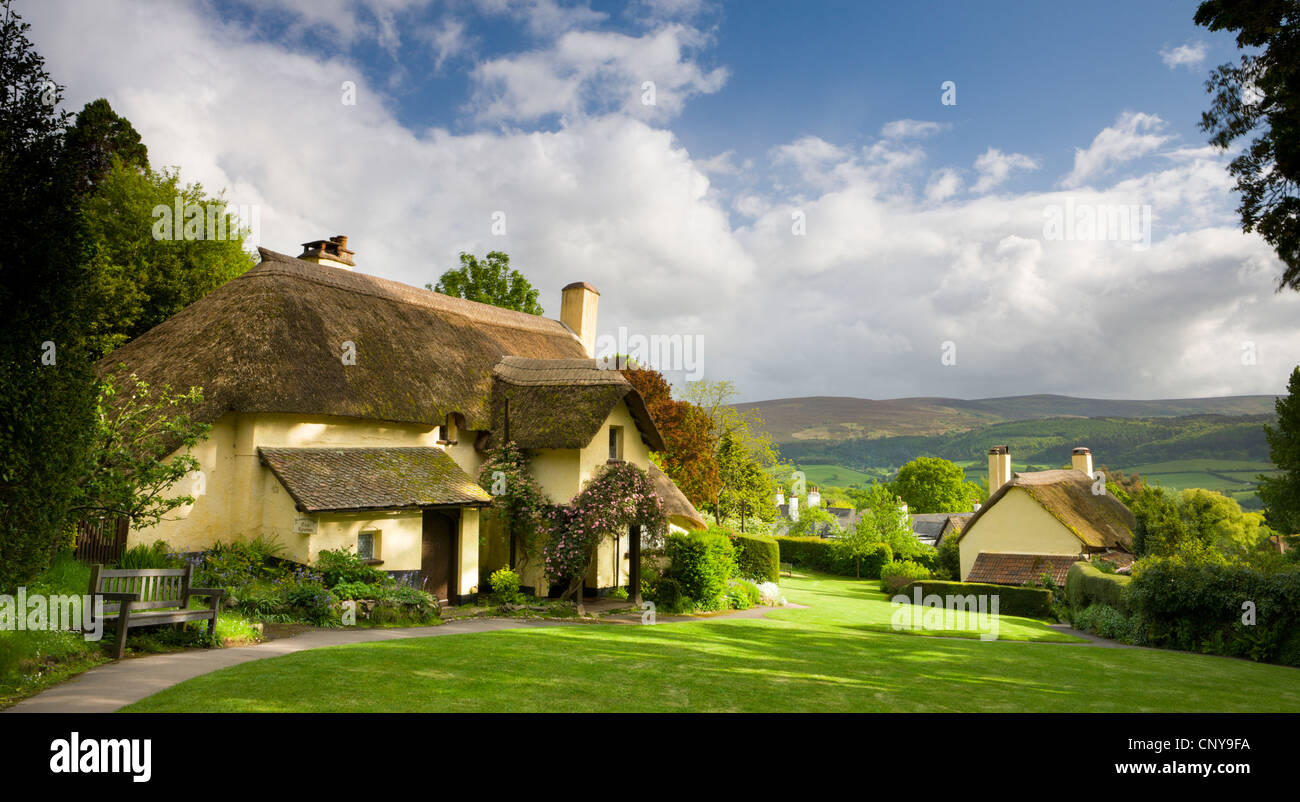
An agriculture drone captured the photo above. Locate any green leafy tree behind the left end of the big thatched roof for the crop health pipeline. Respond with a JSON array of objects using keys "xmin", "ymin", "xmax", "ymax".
[{"xmin": 86, "ymin": 156, "xmax": 255, "ymax": 354}]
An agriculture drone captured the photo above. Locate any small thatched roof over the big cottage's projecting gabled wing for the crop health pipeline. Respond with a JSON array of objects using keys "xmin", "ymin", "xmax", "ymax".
[{"xmin": 489, "ymin": 356, "xmax": 664, "ymax": 451}]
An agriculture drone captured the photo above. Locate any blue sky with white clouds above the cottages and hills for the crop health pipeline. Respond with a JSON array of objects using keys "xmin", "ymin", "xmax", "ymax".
[{"xmin": 18, "ymin": 0, "xmax": 1300, "ymax": 400}]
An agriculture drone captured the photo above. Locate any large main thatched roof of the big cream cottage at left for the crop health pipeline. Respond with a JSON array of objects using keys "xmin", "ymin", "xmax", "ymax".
[{"xmin": 99, "ymin": 248, "xmax": 587, "ymax": 431}]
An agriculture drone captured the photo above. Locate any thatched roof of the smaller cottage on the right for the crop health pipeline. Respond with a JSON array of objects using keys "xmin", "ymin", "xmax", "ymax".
[{"xmin": 959, "ymin": 471, "xmax": 1138, "ymax": 551}]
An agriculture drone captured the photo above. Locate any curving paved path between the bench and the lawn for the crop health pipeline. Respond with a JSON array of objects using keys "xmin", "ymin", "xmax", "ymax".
[{"xmin": 4, "ymin": 604, "xmax": 800, "ymax": 712}]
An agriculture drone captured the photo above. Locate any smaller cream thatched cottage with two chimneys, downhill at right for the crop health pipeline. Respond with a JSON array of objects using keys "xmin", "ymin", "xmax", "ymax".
[{"xmin": 957, "ymin": 446, "xmax": 1136, "ymax": 585}]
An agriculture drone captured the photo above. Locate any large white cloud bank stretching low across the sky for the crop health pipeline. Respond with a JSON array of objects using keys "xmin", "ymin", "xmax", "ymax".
[{"xmin": 26, "ymin": 0, "xmax": 1300, "ymax": 399}]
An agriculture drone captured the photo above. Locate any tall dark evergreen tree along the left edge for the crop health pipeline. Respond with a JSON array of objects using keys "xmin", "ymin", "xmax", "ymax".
[{"xmin": 0, "ymin": 3, "xmax": 95, "ymax": 590}]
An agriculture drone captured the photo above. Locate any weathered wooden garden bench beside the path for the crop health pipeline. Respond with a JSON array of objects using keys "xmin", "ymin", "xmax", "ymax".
[{"xmin": 90, "ymin": 565, "xmax": 226, "ymax": 659}]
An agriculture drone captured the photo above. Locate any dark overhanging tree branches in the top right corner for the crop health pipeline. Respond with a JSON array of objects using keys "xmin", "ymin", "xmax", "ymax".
[{"xmin": 1195, "ymin": 0, "xmax": 1300, "ymax": 290}]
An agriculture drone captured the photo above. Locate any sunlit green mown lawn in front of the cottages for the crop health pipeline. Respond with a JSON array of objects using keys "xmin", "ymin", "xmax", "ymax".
[{"xmin": 126, "ymin": 576, "xmax": 1300, "ymax": 712}]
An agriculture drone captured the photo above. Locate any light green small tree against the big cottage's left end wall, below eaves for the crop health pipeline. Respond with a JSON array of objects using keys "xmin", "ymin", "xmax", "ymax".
[{"xmin": 73, "ymin": 369, "xmax": 211, "ymax": 529}]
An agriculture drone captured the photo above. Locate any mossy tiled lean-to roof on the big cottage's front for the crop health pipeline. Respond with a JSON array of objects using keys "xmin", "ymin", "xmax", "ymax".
[{"xmin": 257, "ymin": 447, "xmax": 491, "ymax": 512}]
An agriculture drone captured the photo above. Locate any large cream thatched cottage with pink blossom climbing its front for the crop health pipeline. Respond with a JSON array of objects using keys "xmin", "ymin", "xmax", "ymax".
[{"xmin": 100, "ymin": 237, "xmax": 703, "ymax": 602}]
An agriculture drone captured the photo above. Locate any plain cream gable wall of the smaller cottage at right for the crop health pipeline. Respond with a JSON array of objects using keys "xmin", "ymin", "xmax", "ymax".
[{"xmin": 958, "ymin": 487, "xmax": 1083, "ymax": 581}]
